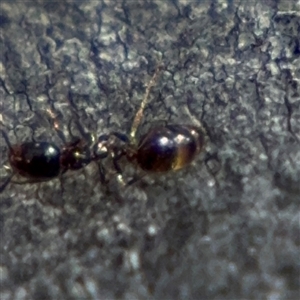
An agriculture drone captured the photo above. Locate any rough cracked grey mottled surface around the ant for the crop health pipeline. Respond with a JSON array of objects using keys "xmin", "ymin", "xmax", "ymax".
[{"xmin": 0, "ymin": 0, "xmax": 300, "ymax": 300}]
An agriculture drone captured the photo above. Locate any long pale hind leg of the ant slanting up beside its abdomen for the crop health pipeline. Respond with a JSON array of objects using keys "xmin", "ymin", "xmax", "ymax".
[{"xmin": 130, "ymin": 65, "xmax": 163, "ymax": 141}]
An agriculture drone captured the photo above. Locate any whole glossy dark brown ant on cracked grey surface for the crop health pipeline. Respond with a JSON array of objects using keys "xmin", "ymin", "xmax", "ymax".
[{"xmin": 0, "ymin": 66, "xmax": 205, "ymax": 192}]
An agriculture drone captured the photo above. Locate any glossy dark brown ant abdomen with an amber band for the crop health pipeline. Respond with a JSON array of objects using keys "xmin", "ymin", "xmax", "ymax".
[{"xmin": 134, "ymin": 125, "xmax": 204, "ymax": 172}]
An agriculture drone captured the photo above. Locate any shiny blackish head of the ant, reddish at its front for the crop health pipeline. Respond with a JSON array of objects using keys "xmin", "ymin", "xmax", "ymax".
[{"xmin": 8, "ymin": 142, "xmax": 61, "ymax": 180}]
